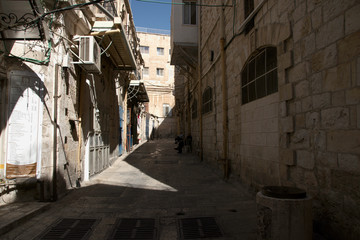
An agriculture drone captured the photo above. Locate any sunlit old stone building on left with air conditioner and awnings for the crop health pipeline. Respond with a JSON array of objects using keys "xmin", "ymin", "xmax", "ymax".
[{"xmin": 0, "ymin": 0, "xmax": 148, "ymax": 204}]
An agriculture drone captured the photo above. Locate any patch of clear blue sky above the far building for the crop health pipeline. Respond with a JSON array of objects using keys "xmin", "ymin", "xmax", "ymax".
[{"xmin": 130, "ymin": 0, "xmax": 171, "ymax": 30}]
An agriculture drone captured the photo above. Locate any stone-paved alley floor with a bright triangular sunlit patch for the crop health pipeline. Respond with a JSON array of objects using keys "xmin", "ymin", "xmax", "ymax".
[{"xmin": 0, "ymin": 139, "xmax": 256, "ymax": 240}]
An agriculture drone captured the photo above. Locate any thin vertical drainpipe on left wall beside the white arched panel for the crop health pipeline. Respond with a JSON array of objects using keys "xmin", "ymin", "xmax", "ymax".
[{"xmin": 51, "ymin": 64, "xmax": 60, "ymax": 201}]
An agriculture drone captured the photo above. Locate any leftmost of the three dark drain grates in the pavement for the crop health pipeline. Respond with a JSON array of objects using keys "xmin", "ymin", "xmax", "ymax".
[{"xmin": 38, "ymin": 218, "xmax": 98, "ymax": 240}]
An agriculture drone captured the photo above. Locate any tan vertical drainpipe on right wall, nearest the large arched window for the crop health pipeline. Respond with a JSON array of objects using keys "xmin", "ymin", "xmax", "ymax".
[{"xmin": 220, "ymin": 7, "xmax": 230, "ymax": 179}]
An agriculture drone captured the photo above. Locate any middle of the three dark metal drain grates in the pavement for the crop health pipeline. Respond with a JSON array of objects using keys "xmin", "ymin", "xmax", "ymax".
[{"xmin": 109, "ymin": 218, "xmax": 157, "ymax": 240}]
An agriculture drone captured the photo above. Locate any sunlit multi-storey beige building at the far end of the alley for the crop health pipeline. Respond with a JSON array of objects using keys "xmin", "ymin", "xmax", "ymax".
[{"xmin": 137, "ymin": 28, "xmax": 177, "ymax": 139}]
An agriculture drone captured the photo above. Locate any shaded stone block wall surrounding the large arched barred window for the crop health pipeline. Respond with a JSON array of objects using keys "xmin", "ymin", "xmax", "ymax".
[{"xmin": 200, "ymin": 0, "xmax": 360, "ymax": 239}]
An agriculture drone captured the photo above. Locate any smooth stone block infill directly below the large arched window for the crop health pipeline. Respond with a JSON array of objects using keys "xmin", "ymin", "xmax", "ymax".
[{"xmin": 238, "ymin": 93, "xmax": 280, "ymax": 186}]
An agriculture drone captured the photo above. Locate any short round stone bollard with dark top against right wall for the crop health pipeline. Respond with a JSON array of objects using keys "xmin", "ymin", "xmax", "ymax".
[{"xmin": 256, "ymin": 186, "xmax": 313, "ymax": 240}]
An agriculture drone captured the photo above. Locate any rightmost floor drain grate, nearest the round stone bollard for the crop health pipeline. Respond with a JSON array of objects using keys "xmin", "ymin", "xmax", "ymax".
[{"xmin": 179, "ymin": 217, "xmax": 223, "ymax": 239}]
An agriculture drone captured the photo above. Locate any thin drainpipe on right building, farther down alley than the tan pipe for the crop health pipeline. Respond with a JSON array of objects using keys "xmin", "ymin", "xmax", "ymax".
[{"xmin": 198, "ymin": 0, "xmax": 204, "ymax": 161}]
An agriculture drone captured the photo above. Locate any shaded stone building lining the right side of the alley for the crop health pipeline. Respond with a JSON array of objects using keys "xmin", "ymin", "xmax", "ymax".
[{"xmin": 171, "ymin": 0, "xmax": 360, "ymax": 239}]
